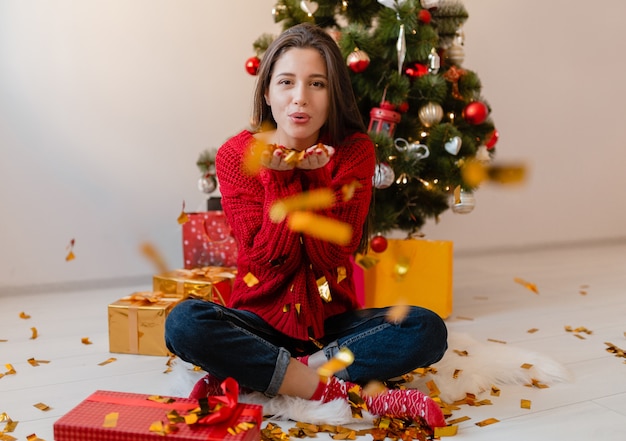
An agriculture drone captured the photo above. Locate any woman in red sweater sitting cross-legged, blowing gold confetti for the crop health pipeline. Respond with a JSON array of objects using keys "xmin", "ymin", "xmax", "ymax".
[{"xmin": 166, "ymin": 24, "xmax": 447, "ymax": 426}]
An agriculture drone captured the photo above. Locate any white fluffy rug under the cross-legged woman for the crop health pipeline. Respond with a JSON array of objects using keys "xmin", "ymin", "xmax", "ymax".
[{"xmin": 169, "ymin": 332, "xmax": 572, "ymax": 425}]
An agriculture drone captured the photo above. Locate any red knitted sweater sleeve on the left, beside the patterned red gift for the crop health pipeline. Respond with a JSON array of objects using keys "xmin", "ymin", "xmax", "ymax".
[{"xmin": 215, "ymin": 132, "xmax": 302, "ymax": 279}]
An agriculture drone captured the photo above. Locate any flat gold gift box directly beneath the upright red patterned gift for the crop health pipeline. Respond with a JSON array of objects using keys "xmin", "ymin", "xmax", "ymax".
[{"xmin": 152, "ymin": 266, "xmax": 237, "ymax": 305}]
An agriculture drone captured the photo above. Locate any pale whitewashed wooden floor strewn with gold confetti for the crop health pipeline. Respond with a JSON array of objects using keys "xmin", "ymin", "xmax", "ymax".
[{"xmin": 0, "ymin": 242, "xmax": 626, "ymax": 441}]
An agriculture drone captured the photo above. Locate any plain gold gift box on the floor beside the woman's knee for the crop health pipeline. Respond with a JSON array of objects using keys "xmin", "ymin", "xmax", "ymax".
[{"xmin": 108, "ymin": 292, "xmax": 181, "ymax": 355}]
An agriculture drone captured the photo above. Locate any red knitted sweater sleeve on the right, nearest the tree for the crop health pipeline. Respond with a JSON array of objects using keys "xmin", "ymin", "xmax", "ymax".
[{"xmin": 303, "ymin": 134, "xmax": 376, "ymax": 269}]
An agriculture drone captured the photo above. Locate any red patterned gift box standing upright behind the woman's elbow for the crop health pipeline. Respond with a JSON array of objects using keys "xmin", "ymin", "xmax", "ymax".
[{"xmin": 183, "ymin": 210, "xmax": 237, "ymax": 269}]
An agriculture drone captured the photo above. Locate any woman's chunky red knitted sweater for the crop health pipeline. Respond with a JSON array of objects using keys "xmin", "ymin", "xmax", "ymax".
[{"xmin": 215, "ymin": 130, "xmax": 375, "ymax": 340}]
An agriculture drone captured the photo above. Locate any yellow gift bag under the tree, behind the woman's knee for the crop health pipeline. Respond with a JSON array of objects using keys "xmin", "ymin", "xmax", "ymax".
[{"xmin": 356, "ymin": 239, "xmax": 452, "ymax": 318}]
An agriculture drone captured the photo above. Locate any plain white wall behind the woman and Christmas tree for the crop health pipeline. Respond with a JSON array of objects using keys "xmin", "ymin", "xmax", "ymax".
[{"xmin": 0, "ymin": 0, "xmax": 626, "ymax": 294}]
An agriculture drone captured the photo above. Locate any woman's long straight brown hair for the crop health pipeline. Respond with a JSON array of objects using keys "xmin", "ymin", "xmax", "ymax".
[{"xmin": 252, "ymin": 22, "xmax": 366, "ymax": 145}]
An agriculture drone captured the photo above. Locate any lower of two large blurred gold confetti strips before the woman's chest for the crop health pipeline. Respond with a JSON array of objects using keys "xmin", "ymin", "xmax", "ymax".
[{"xmin": 287, "ymin": 211, "xmax": 352, "ymax": 245}]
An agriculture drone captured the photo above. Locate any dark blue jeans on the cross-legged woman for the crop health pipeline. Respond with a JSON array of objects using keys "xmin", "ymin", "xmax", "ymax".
[{"xmin": 165, "ymin": 299, "xmax": 447, "ymax": 397}]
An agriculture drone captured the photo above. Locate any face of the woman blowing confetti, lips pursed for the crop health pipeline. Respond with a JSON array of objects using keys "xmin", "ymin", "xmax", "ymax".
[{"xmin": 265, "ymin": 48, "xmax": 329, "ymax": 150}]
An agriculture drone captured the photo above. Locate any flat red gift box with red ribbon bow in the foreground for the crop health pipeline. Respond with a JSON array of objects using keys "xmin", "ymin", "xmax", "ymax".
[{"xmin": 54, "ymin": 378, "xmax": 263, "ymax": 441}]
